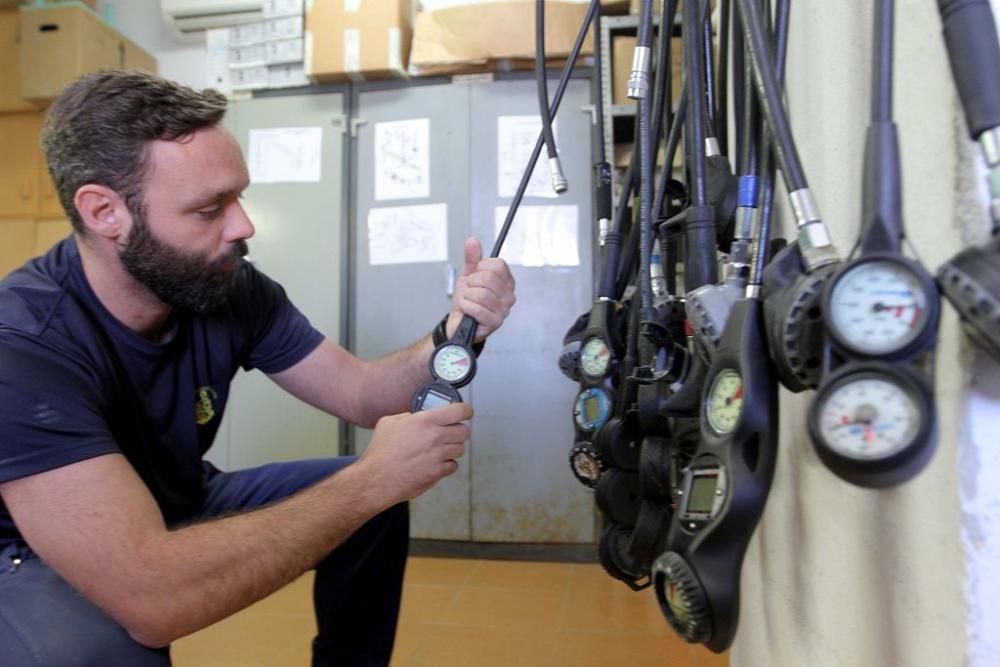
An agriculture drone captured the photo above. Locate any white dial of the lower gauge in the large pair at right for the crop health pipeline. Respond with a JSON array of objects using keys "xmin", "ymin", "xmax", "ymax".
[{"xmin": 819, "ymin": 376, "xmax": 924, "ymax": 460}]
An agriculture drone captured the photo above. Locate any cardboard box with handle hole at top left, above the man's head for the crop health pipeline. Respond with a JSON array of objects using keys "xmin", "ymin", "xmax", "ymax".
[{"xmin": 18, "ymin": 4, "xmax": 156, "ymax": 106}]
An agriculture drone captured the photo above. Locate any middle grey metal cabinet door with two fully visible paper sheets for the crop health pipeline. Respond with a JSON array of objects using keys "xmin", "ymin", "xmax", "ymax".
[{"xmin": 351, "ymin": 84, "xmax": 476, "ymax": 540}]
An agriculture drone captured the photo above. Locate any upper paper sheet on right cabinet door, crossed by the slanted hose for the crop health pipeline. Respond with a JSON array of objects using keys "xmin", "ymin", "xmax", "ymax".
[{"xmin": 497, "ymin": 116, "xmax": 558, "ymax": 197}]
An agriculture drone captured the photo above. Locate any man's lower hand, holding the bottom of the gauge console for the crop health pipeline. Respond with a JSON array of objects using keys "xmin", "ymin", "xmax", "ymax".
[{"xmin": 355, "ymin": 403, "xmax": 472, "ymax": 504}]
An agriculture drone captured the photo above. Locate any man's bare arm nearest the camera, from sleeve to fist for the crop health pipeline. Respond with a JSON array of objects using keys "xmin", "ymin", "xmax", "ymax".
[{"xmin": 0, "ymin": 404, "xmax": 472, "ymax": 646}]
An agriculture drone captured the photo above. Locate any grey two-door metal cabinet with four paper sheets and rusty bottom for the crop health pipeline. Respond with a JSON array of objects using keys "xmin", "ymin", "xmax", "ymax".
[{"xmin": 351, "ymin": 79, "xmax": 594, "ymax": 543}]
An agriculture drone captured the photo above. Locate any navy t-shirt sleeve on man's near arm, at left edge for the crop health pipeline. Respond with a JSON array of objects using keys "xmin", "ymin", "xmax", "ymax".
[{"xmin": 0, "ymin": 331, "xmax": 121, "ymax": 482}]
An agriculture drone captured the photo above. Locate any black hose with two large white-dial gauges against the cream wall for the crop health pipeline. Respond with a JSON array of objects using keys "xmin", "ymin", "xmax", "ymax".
[{"xmin": 809, "ymin": 0, "xmax": 940, "ymax": 487}]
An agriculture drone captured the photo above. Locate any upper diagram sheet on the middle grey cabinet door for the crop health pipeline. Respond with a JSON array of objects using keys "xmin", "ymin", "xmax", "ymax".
[{"xmin": 375, "ymin": 118, "xmax": 431, "ymax": 201}]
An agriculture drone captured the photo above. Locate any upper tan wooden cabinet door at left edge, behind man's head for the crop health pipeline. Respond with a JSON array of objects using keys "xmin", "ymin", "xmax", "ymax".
[{"xmin": 0, "ymin": 111, "xmax": 42, "ymax": 217}]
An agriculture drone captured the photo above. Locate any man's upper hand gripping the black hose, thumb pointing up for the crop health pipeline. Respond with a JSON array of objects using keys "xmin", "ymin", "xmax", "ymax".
[{"xmin": 445, "ymin": 238, "xmax": 515, "ymax": 342}]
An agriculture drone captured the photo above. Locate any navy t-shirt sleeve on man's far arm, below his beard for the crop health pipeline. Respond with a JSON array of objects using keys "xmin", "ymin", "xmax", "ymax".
[{"xmin": 234, "ymin": 264, "xmax": 323, "ymax": 373}]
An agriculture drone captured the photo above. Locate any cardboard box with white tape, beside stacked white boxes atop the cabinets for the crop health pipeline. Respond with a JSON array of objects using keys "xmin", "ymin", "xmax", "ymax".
[{"xmin": 305, "ymin": 0, "xmax": 412, "ymax": 83}]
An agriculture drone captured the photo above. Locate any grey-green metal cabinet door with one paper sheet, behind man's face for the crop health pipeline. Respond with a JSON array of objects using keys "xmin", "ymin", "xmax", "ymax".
[{"xmin": 209, "ymin": 93, "xmax": 346, "ymax": 469}]
